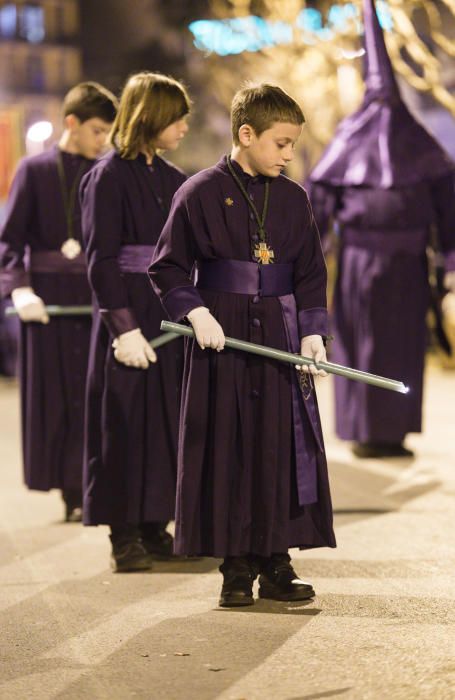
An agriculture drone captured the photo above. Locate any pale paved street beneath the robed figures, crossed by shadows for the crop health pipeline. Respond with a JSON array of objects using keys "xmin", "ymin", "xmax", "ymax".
[{"xmin": 0, "ymin": 366, "xmax": 455, "ymax": 700}]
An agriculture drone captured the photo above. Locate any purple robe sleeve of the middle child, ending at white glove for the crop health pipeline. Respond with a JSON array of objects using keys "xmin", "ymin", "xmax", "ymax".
[{"xmin": 80, "ymin": 168, "xmax": 139, "ymax": 336}]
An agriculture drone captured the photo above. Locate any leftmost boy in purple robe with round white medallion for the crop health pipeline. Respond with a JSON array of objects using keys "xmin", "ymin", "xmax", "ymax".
[{"xmin": 0, "ymin": 82, "xmax": 116, "ymax": 521}]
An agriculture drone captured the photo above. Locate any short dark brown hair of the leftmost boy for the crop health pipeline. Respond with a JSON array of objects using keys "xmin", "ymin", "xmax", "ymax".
[{"xmin": 63, "ymin": 82, "xmax": 118, "ymax": 124}]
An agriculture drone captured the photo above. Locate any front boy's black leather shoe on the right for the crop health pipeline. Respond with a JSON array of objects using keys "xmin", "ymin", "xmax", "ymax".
[{"xmin": 259, "ymin": 554, "xmax": 316, "ymax": 601}]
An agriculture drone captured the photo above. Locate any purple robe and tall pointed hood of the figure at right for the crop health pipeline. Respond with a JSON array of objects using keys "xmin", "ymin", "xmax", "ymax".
[{"xmin": 309, "ymin": 0, "xmax": 455, "ymax": 443}]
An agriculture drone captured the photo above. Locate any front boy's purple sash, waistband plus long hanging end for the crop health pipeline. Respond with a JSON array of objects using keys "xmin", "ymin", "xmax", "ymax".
[{"xmin": 196, "ymin": 260, "xmax": 324, "ymax": 506}]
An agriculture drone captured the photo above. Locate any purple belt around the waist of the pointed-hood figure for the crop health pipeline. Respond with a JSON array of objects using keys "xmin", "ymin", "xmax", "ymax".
[{"xmin": 341, "ymin": 228, "xmax": 428, "ymax": 255}]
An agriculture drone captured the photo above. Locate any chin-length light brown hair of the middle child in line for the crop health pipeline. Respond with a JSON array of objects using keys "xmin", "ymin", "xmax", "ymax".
[{"xmin": 110, "ymin": 71, "xmax": 191, "ymax": 159}]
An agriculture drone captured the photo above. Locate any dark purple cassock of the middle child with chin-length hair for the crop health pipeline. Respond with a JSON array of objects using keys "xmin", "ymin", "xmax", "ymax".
[{"xmin": 80, "ymin": 151, "xmax": 185, "ymax": 525}]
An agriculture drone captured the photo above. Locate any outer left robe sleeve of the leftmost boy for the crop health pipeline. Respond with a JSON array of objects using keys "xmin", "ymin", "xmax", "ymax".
[{"xmin": 0, "ymin": 161, "xmax": 34, "ymax": 296}]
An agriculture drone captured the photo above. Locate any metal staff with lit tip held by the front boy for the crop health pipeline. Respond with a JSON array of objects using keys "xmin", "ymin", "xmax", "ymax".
[{"xmin": 161, "ymin": 321, "xmax": 409, "ymax": 394}]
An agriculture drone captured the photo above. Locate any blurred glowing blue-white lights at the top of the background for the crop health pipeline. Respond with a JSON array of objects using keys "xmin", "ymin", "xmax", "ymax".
[{"xmin": 189, "ymin": 0, "xmax": 393, "ymax": 56}]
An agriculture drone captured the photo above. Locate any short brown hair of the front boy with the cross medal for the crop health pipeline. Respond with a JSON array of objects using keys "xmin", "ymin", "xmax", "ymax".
[{"xmin": 231, "ymin": 83, "xmax": 305, "ymax": 145}]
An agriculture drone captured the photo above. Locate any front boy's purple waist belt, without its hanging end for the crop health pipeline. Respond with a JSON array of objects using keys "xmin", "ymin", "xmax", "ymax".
[{"xmin": 196, "ymin": 260, "xmax": 294, "ymax": 297}]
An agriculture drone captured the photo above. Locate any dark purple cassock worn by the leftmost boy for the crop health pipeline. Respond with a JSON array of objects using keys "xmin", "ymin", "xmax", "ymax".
[{"xmin": 0, "ymin": 147, "xmax": 93, "ymax": 492}]
